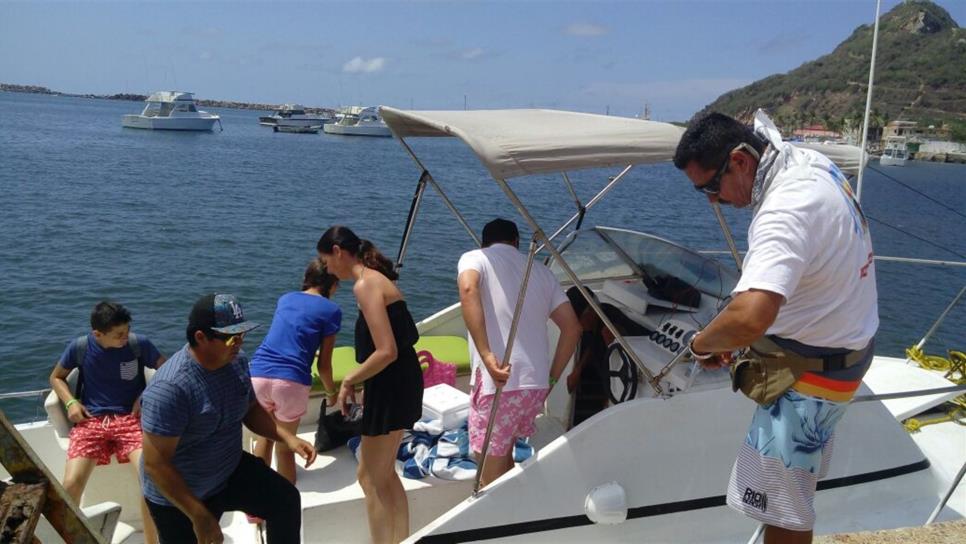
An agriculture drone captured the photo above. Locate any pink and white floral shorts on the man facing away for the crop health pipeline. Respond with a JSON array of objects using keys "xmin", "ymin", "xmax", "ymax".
[{"xmin": 468, "ymin": 372, "xmax": 550, "ymax": 457}]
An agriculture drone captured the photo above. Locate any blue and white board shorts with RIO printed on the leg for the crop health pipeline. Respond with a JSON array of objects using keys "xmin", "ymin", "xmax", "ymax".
[{"xmin": 728, "ymin": 389, "xmax": 848, "ymax": 531}]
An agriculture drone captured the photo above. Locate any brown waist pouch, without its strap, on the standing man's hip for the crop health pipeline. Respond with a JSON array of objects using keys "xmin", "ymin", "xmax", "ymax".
[{"xmin": 731, "ymin": 336, "xmax": 808, "ymax": 406}]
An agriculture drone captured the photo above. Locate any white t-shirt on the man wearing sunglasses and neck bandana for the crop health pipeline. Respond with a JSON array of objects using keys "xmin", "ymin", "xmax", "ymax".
[{"xmin": 734, "ymin": 115, "xmax": 879, "ymax": 349}]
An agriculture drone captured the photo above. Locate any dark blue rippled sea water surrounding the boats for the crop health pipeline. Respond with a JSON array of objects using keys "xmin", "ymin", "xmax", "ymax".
[{"xmin": 0, "ymin": 93, "xmax": 966, "ymax": 421}]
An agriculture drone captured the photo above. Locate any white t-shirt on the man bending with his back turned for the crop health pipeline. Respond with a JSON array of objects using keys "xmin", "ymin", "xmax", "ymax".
[{"xmin": 457, "ymin": 243, "xmax": 567, "ymax": 395}]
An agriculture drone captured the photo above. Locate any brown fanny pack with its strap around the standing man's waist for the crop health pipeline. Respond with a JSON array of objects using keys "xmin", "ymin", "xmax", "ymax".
[{"xmin": 731, "ymin": 336, "xmax": 872, "ymax": 406}]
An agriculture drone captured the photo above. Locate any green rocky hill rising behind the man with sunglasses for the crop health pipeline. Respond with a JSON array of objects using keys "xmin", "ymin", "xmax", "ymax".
[{"xmin": 698, "ymin": 0, "xmax": 966, "ymax": 140}]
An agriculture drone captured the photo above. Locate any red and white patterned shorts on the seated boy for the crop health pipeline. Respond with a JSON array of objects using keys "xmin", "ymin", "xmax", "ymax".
[{"xmin": 67, "ymin": 414, "xmax": 141, "ymax": 465}]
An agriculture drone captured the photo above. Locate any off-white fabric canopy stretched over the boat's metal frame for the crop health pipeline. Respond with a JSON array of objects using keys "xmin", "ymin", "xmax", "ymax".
[{"xmin": 379, "ymin": 106, "xmax": 859, "ymax": 179}]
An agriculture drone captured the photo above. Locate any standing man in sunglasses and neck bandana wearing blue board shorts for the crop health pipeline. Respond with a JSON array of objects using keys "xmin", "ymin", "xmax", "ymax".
[{"xmin": 674, "ymin": 110, "xmax": 879, "ymax": 544}]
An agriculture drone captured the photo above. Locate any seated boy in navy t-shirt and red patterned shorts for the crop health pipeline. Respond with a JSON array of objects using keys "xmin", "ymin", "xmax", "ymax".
[{"xmin": 50, "ymin": 301, "xmax": 164, "ymax": 544}]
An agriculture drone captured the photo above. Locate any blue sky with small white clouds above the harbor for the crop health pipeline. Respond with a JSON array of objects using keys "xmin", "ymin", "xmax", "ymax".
[{"xmin": 0, "ymin": 0, "xmax": 966, "ymax": 121}]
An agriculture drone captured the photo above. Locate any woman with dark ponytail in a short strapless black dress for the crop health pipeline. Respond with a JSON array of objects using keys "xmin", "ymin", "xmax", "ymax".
[{"xmin": 316, "ymin": 226, "xmax": 423, "ymax": 544}]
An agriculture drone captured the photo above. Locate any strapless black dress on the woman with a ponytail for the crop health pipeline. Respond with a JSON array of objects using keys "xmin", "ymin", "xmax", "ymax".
[{"xmin": 355, "ymin": 300, "xmax": 423, "ymax": 436}]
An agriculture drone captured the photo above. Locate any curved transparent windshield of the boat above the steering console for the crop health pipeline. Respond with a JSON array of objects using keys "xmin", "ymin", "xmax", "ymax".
[{"xmin": 551, "ymin": 227, "xmax": 738, "ymax": 299}]
